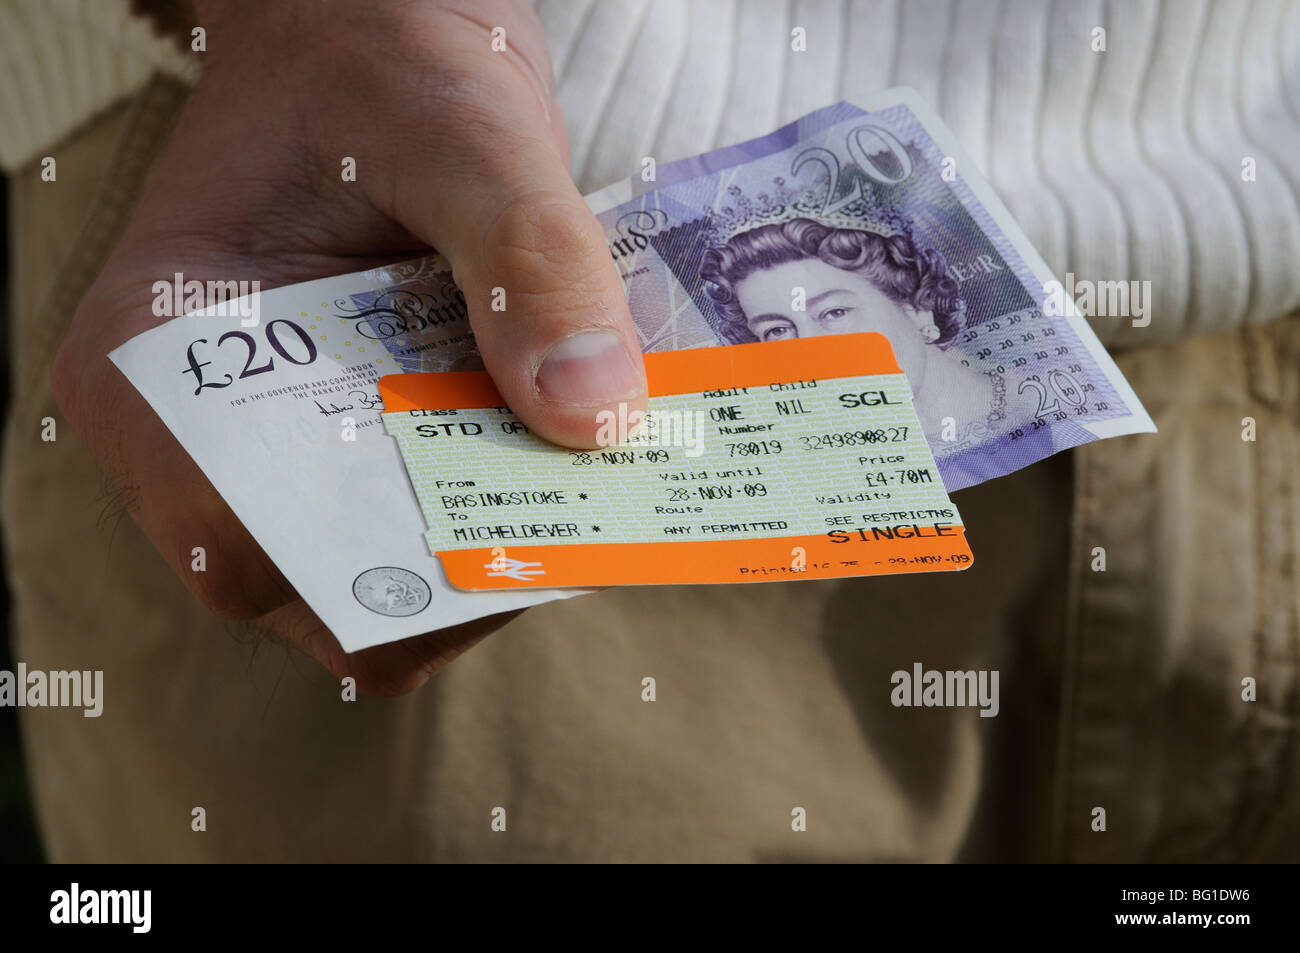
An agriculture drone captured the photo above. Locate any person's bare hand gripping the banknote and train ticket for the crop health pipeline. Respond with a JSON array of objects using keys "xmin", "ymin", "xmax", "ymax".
[{"xmin": 51, "ymin": 0, "xmax": 646, "ymax": 694}]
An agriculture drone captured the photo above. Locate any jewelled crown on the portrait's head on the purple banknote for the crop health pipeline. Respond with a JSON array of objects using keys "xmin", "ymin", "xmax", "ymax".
[{"xmin": 707, "ymin": 176, "xmax": 911, "ymax": 248}]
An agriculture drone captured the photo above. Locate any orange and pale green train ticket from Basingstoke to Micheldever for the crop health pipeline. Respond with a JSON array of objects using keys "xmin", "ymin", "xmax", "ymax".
[{"xmin": 380, "ymin": 333, "xmax": 972, "ymax": 590}]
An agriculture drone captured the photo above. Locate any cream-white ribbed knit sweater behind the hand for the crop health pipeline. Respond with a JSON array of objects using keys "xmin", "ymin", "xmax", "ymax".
[{"xmin": 0, "ymin": 0, "xmax": 1300, "ymax": 345}]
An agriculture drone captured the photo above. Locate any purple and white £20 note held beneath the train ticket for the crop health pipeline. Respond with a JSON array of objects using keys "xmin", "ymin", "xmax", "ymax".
[{"xmin": 109, "ymin": 90, "xmax": 1154, "ymax": 651}]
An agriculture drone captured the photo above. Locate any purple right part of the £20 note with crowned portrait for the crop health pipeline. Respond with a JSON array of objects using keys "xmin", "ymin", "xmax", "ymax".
[{"xmin": 588, "ymin": 88, "xmax": 1156, "ymax": 493}]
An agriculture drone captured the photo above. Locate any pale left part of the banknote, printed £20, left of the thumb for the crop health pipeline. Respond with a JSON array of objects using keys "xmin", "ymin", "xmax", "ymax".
[{"xmin": 109, "ymin": 256, "xmax": 581, "ymax": 651}]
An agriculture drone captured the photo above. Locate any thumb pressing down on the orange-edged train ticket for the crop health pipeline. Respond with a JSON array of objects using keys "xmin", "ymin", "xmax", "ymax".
[{"xmin": 399, "ymin": 112, "xmax": 646, "ymax": 447}]
